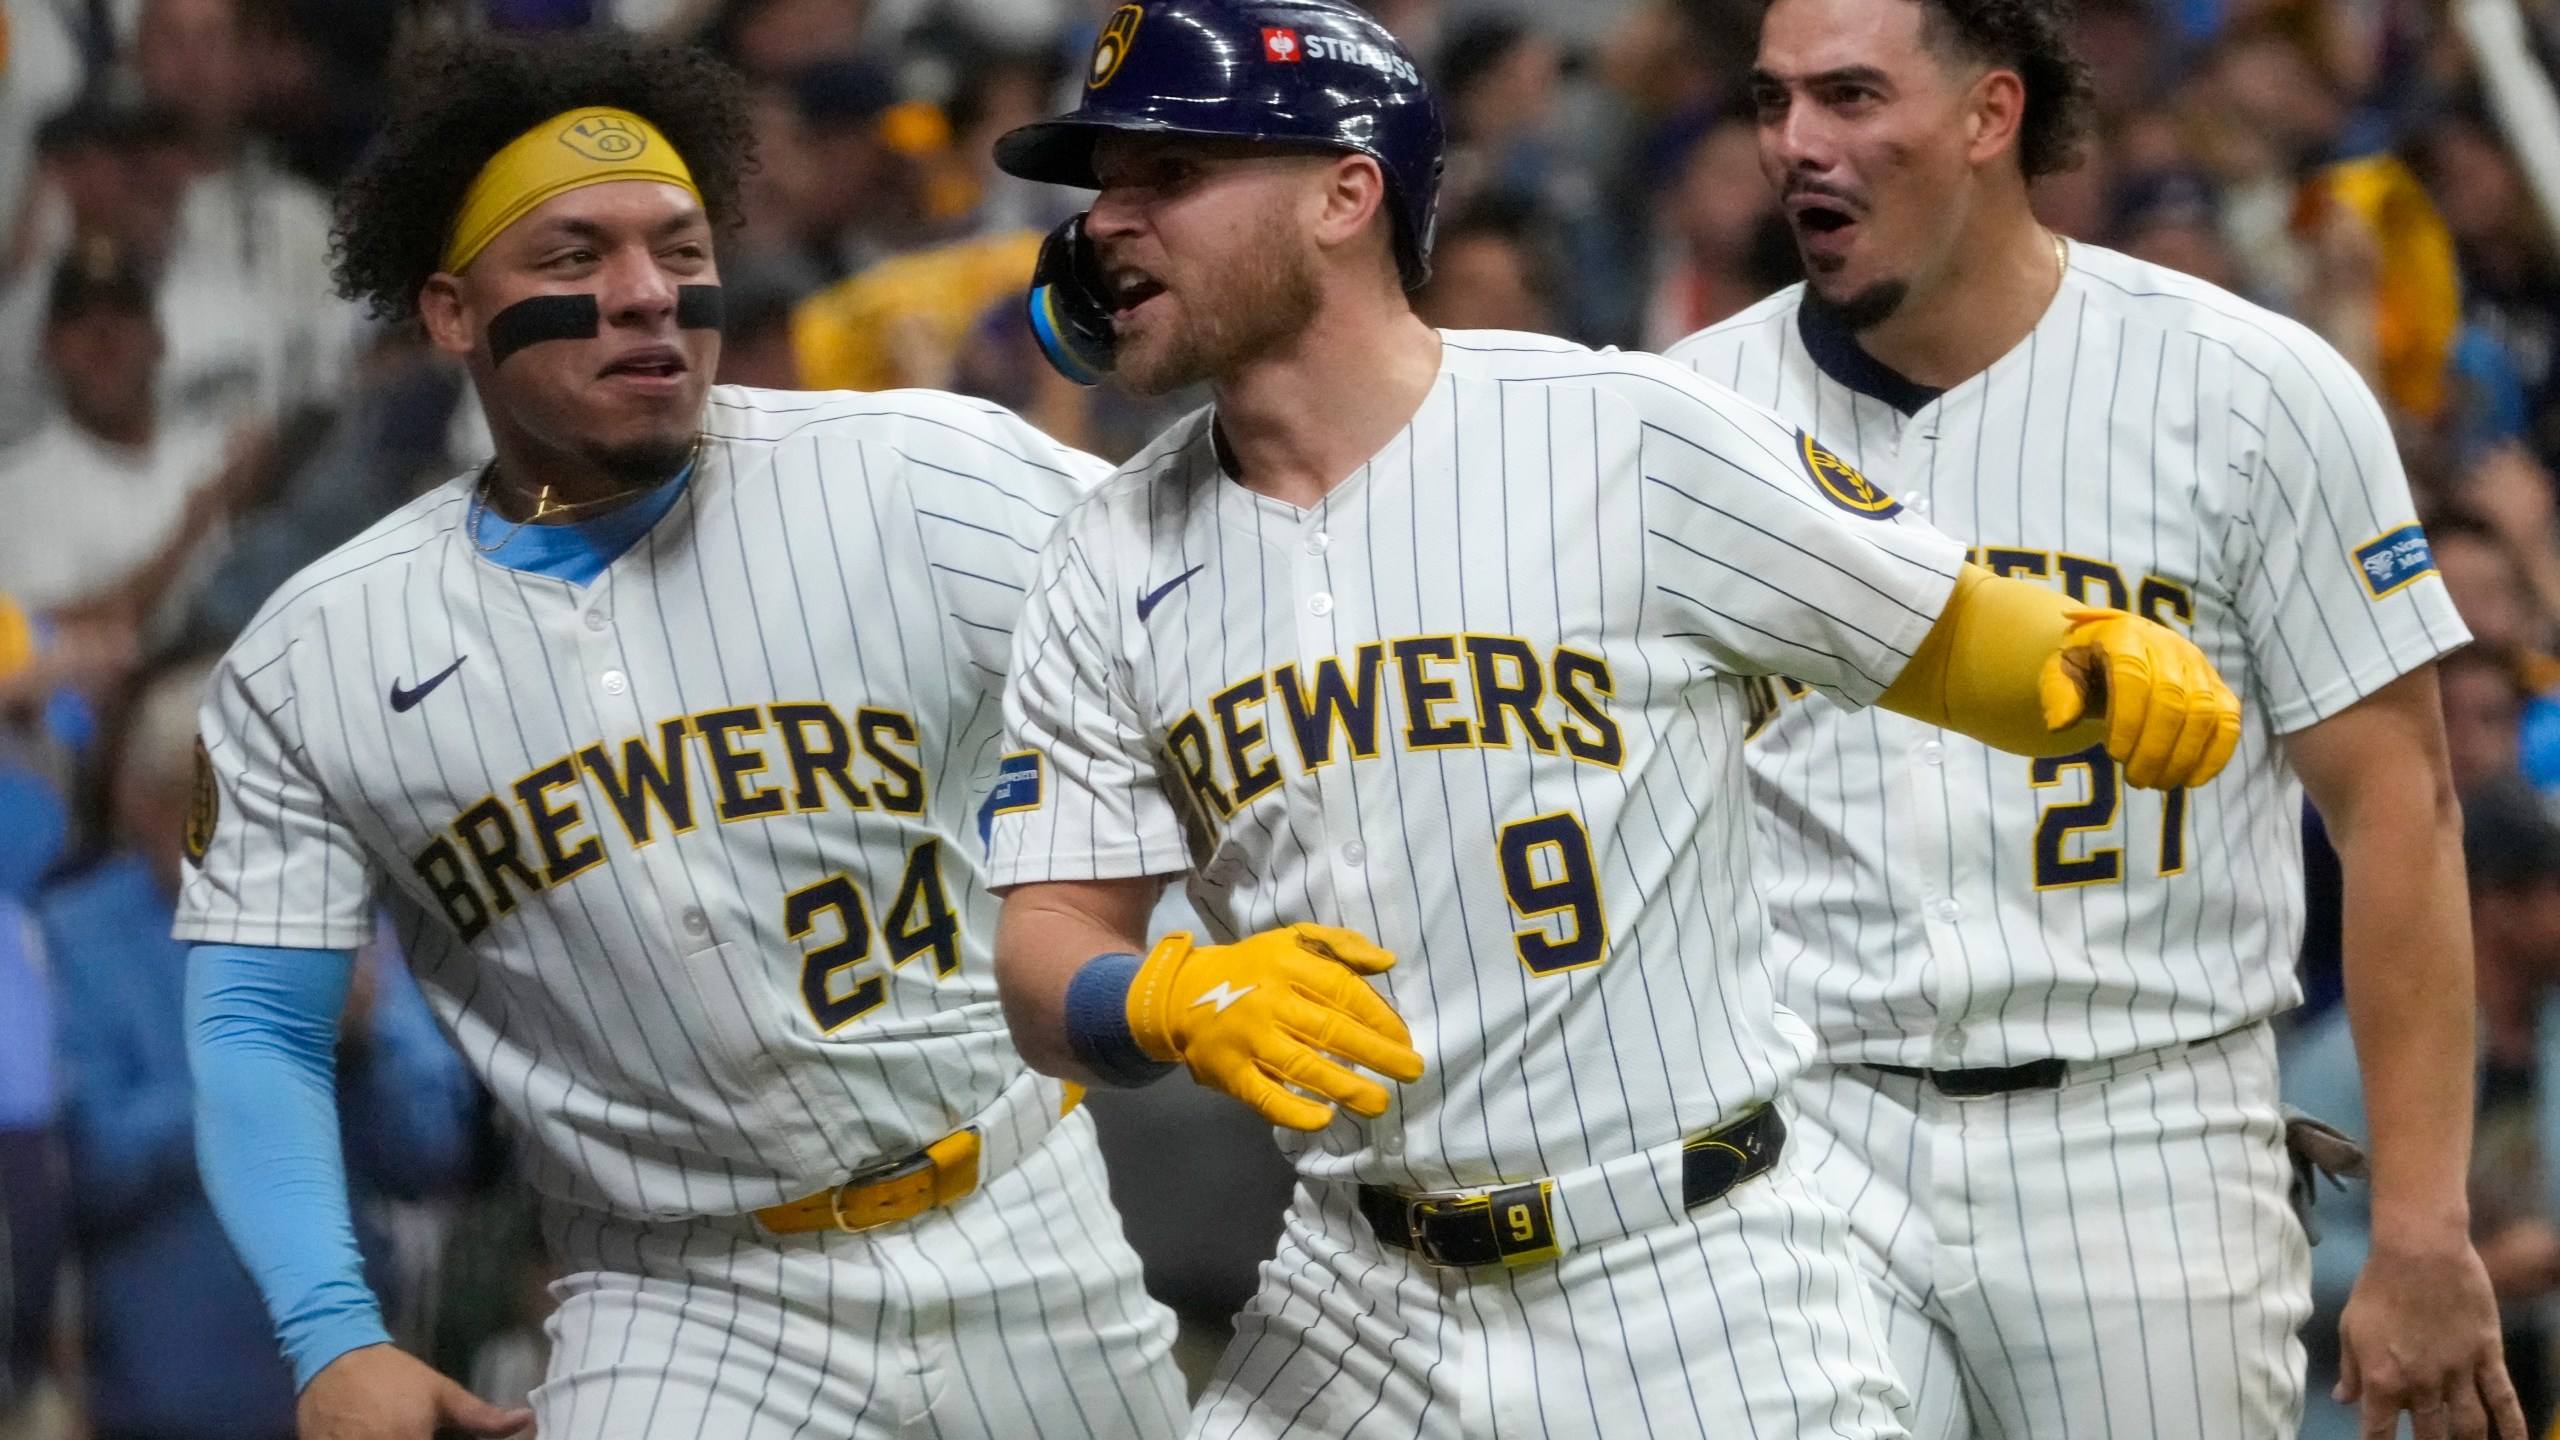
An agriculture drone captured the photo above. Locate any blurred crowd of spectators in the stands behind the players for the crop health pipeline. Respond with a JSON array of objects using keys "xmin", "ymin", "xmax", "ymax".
[{"xmin": 0, "ymin": 0, "xmax": 2560, "ymax": 1440}]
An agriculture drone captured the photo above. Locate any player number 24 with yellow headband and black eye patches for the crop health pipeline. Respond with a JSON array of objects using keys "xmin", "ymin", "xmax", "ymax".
[{"xmin": 179, "ymin": 30, "xmax": 1180, "ymax": 1440}]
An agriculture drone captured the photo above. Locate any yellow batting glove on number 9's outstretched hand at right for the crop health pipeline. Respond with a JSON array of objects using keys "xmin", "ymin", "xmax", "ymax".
[{"xmin": 2038, "ymin": 610, "xmax": 2240, "ymax": 789}]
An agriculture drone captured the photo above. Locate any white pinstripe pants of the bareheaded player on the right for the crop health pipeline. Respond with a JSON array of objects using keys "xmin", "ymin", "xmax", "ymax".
[{"xmin": 1797, "ymin": 1025, "xmax": 2312, "ymax": 1440}]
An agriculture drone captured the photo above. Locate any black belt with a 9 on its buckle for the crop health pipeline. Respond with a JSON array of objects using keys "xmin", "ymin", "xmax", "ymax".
[{"xmin": 1359, "ymin": 1107, "xmax": 1787, "ymax": 1266}]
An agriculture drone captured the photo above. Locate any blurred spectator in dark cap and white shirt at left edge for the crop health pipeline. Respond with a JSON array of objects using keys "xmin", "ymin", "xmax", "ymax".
[{"xmin": 0, "ymin": 243, "xmax": 266, "ymax": 625}]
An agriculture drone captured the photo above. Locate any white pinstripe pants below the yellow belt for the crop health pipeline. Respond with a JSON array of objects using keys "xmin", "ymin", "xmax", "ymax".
[{"xmin": 532, "ymin": 1112, "xmax": 1183, "ymax": 1440}]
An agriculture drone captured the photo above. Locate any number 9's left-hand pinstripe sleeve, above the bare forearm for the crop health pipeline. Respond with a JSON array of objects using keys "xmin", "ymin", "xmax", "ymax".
[{"xmin": 988, "ymin": 453, "xmax": 1190, "ymax": 887}]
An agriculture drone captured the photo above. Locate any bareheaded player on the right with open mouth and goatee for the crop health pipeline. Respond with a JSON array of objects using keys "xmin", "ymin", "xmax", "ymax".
[{"xmin": 1672, "ymin": 0, "xmax": 2522, "ymax": 1440}]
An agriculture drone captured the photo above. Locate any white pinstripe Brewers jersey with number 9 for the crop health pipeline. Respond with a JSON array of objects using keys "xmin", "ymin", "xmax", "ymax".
[{"xmin": 993, "ymin": 331, "xmax": 1961, "ymax": 1189}]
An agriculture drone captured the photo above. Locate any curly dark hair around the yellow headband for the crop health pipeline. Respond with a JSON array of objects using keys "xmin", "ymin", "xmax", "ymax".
[{"xmin": 330, "ymin": 33, "xmax": 753, "ymax": 320}]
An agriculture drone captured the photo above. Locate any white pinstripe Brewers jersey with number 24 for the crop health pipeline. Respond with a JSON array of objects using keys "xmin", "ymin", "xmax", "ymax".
[{"xmin": 179, "ymin": 387, "xmax": 1103, "ymax": 1217}]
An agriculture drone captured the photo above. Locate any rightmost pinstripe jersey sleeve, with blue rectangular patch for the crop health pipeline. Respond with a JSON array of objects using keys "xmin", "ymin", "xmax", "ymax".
[{"xmin": 2235, "ymin": 331, "xmax": 2468, "ymax": 735}]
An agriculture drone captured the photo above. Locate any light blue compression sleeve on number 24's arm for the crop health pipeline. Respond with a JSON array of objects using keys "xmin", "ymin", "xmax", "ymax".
[{"xmin": 187, "ymin": 945, "xmax": 392, "ymax": 1389}]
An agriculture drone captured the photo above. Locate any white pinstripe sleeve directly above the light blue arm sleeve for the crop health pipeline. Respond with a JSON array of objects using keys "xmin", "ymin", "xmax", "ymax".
[{"xmin": 177, "ymin": 628, "xmax": 374, "ymax": 951}]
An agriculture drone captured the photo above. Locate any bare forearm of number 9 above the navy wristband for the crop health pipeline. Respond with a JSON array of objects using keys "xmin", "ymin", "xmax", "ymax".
[{"xmin": 996, "ymin": 879, "xmax": 1160, "ymax": 1084}]
